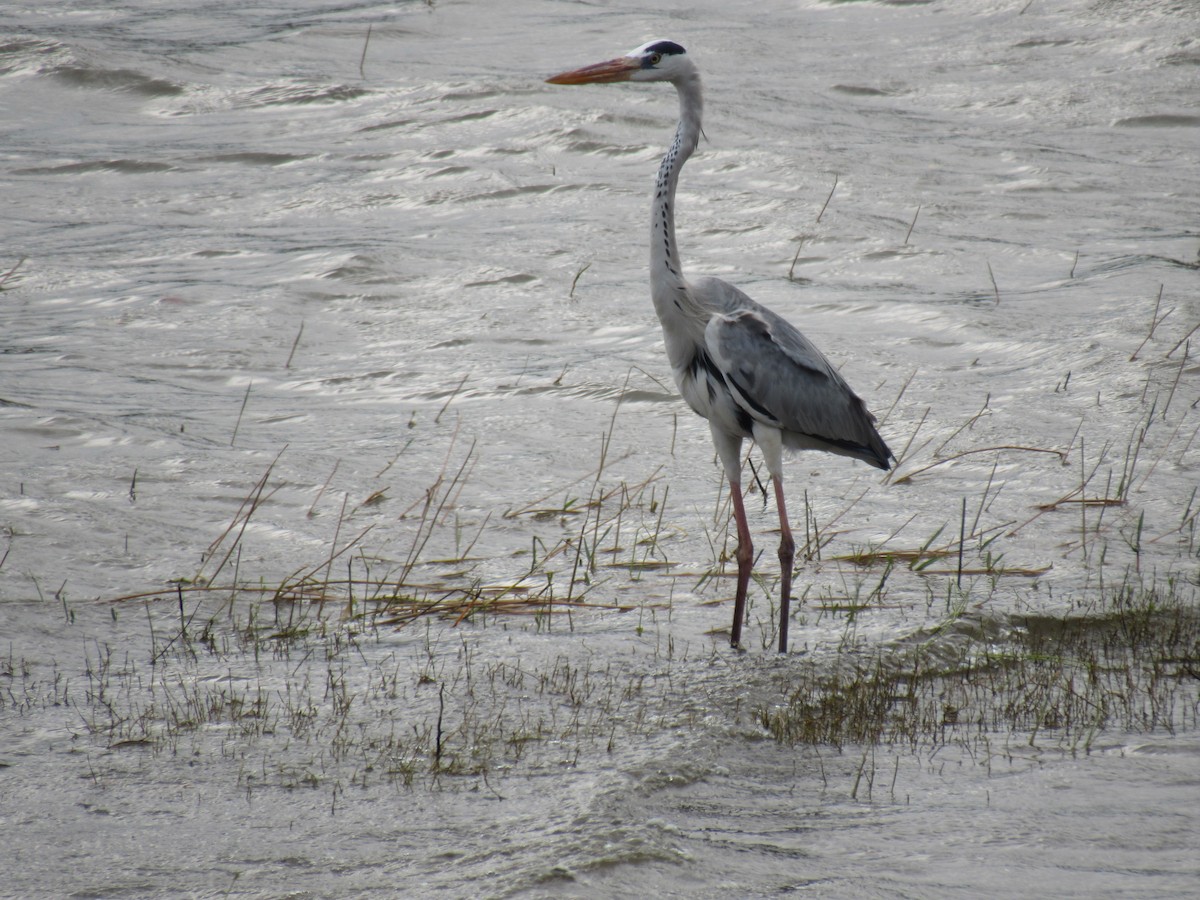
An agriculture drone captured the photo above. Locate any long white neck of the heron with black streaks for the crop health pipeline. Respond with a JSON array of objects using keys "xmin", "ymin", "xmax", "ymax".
[{"xmin": 650, "ymin": 74, "xmax": 704, "ymax": 309}]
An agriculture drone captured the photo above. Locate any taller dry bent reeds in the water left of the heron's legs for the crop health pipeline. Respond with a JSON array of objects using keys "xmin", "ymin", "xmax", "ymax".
[{"xmin": 175, "ymin": 414, "xmax": 673, "ymax": 626}]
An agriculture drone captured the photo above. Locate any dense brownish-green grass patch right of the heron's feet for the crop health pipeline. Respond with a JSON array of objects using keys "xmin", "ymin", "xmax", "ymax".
[{"xmin": 756, "ymin": 577, "xmax": 1200, "ymax": 752}]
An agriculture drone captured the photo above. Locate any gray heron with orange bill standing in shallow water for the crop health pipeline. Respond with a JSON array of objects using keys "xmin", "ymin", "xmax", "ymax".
[{"xmin": 546, "ymin": 41, "xmax": 895, "ymax": 653}]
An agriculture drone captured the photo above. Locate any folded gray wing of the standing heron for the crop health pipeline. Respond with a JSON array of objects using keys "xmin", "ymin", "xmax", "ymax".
[{"xmin": 694, "ymin": 278, "xmax": 892, "ymax": 469}]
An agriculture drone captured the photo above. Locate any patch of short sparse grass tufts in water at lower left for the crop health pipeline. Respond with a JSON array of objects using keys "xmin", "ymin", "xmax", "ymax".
[{"xmin": 25, "ymin": 598, "xmax": 673, "ymax": 796}]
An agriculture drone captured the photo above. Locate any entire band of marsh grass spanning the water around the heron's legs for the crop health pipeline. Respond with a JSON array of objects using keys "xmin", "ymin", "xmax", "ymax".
[{"xmin": 0, "ymin": 354, "xmax": 1200, "ymax": 812}]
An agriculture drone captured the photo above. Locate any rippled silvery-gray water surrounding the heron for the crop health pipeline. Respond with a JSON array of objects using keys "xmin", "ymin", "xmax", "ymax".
[{"xmin": 0, "ymin": 0, "xmax": 1200, "ymax": 896}]
